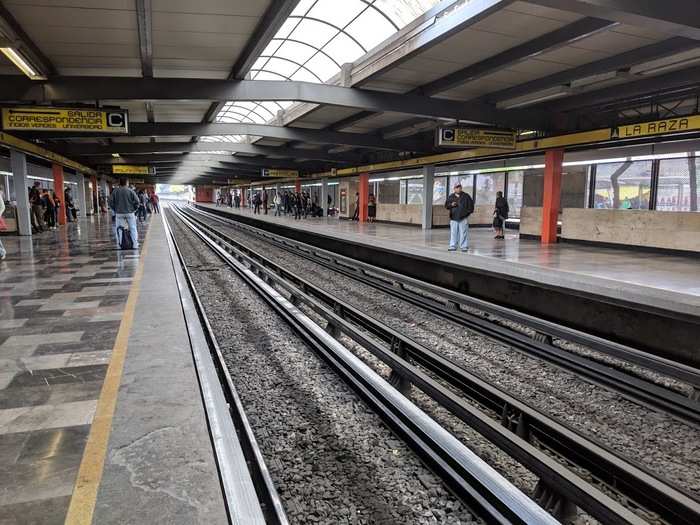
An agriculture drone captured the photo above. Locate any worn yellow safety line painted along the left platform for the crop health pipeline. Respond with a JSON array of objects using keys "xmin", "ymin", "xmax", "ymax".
[{"xmin": 65, "ymin": 229, "xmax": 150, "ymax": 525}]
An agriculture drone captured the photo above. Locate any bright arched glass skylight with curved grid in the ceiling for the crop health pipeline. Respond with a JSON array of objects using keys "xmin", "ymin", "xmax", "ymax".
[{"xmin": 202, "ymin": 0, "xmax": 440, "ymax": 142}]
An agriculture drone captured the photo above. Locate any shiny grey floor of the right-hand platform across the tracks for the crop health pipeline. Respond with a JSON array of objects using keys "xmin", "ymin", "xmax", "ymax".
[{"xmin": 198, "ymin": 204, "xmax": 700, "ymax": 315}]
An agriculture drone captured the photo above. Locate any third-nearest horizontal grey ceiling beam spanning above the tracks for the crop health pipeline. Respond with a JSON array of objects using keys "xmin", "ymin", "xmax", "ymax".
[{"xmin": 60, "ymin": 142, "xmax": 359, "ymax": 164}]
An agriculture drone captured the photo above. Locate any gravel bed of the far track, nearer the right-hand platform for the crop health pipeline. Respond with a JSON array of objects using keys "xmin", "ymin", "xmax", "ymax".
[{"xmin": 190, "ymin": 209, "xmax": 700, "ymax": 498}]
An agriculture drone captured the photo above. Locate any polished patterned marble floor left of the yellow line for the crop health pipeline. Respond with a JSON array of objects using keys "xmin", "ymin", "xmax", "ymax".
[{"xmin": 0, "ymin": 217, "xmax": 146, "ymax": 525}]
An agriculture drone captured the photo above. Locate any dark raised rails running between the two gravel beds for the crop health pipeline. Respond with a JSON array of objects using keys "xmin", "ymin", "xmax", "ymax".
[{"xmin": 172, "ymin": 205, "xmax": 700, "ymax": 524}]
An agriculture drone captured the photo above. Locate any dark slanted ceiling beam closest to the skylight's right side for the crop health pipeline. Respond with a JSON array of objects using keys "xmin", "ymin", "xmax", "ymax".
[{"xmin": 411, "ymin": 18, "xmax": 618, "ymax": 96}]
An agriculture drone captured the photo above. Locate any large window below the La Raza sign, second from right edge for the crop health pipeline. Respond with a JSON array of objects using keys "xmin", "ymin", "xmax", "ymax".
[{"xmin": 594, "ymin": 160, "xmax": 652, "ymax": 210}]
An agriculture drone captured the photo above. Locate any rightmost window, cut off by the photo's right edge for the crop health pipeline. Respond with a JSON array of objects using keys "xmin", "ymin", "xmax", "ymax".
[{"xmin": 656, "ymin": 157, "xmax": 700, "ymax": 211}]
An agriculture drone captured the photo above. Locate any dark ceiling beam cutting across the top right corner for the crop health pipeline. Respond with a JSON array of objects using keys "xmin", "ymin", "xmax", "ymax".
[{"xmin": 528, "ymin": 0, "xmax": 700, "ymax": 39}]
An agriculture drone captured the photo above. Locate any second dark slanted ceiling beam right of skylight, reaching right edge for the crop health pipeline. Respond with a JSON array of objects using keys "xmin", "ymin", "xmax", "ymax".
[{"xmin": 485, "ymin": 37, "xmax": 700, "ymax": 104}]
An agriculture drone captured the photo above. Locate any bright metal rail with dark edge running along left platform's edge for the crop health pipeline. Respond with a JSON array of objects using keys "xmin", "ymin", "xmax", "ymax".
[{"xmin": 161, "ymin": 209, "xmax": 289, "ymax": 525}]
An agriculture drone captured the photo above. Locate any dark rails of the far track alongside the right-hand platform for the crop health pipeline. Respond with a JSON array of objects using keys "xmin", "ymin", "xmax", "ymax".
[{"xmin": 190, "ymin": 204, "xmax": 700, "ymax": 418}]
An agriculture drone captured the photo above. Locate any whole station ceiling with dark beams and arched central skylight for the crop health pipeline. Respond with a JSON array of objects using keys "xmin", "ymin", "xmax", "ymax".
[{"xmin": 0, "ymin": 0, "xmax": 700, "ymax": 184}]
